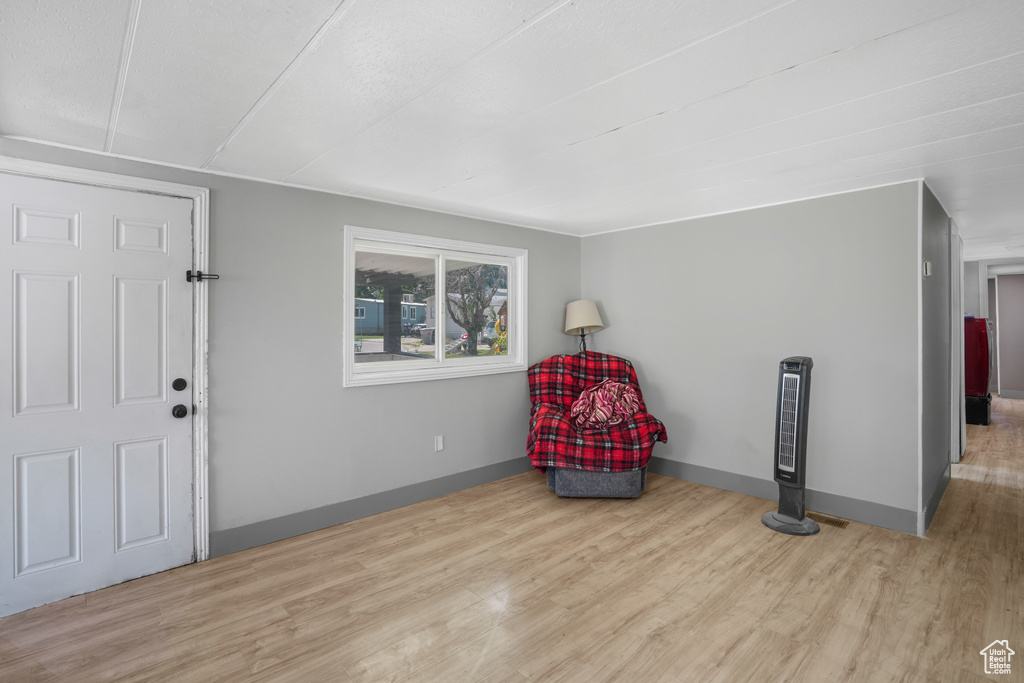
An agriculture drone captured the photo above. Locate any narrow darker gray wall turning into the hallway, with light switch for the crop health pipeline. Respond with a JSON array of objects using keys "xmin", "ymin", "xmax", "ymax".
[{"xmin": 919, "ymin": 185, "xmax": 952, "ymax": 532}]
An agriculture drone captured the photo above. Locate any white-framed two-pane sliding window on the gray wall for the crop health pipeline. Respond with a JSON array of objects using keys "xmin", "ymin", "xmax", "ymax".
[{"xmin": 342, "ymin": 225, "xmax": 526, "ymax": 387}]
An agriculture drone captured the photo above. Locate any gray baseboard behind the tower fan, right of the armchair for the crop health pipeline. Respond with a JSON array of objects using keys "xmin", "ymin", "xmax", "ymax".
[{"xmin": 647, "ymin": 458, "xmax": 917, "ymax": 536}]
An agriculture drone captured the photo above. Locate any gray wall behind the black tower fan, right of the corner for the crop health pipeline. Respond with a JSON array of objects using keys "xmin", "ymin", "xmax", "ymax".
[{"xmin": 583, "ymin": 182, "xmax": 925, "ymax": 516}]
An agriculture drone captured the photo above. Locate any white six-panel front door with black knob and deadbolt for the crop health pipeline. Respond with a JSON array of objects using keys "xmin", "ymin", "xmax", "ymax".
[{"xmin": 0, "ymin": 174, "xmax": 195, "ymax": 616}]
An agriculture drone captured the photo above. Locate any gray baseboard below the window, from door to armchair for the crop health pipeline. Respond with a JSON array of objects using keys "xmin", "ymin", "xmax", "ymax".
[{"xmin": 210, "ymin": 456, "xmax": 532, "ymax": 558}]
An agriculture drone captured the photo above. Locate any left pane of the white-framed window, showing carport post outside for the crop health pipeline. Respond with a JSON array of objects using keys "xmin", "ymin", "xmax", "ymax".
[{"xmin": 354, "ymin": 248, "xmax": 435, "ymax": 364}]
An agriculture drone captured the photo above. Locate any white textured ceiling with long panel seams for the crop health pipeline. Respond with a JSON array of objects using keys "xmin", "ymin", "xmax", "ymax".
[{"xmin": 0, "ymin": 0, "xmax": 1024, "ymax": 256}]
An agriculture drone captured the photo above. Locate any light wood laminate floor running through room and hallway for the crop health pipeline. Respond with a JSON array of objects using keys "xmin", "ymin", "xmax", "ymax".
[{"xmin": 0, "ymin": 399, "xmax": 1024, "ymax": 683}]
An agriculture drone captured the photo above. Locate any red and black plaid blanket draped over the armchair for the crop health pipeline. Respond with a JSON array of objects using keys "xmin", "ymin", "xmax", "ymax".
[{"xmin": 526, "ymin": 351, "xmax": 668, "ymax": 472}]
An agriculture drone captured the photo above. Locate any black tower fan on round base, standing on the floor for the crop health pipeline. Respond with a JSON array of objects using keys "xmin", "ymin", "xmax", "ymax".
[{"xmin": 761, "ymin": 355, "xmax": 818, "ymax": 536}]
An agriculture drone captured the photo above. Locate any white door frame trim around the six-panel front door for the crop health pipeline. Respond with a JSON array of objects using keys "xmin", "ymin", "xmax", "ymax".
[{"xmin": 0, "ymin": 156, "xmax": 210, "ymax": 562}]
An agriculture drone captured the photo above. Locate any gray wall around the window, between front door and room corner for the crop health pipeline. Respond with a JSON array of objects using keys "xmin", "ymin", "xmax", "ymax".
[{"xmin": 0, "ymin": 139, "xmax": 581, "ymax": 532}]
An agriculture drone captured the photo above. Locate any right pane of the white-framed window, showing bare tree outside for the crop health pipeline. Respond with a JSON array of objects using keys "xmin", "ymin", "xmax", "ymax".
[{"xmin": 443, "ymin": 259, "xmax": 509, "ymax": 358}]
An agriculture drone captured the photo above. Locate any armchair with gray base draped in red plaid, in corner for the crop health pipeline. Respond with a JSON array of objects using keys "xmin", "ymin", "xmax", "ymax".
[{"xmin": 526, "ymin": 351, "xmax": 668, "ymax": 498}]
